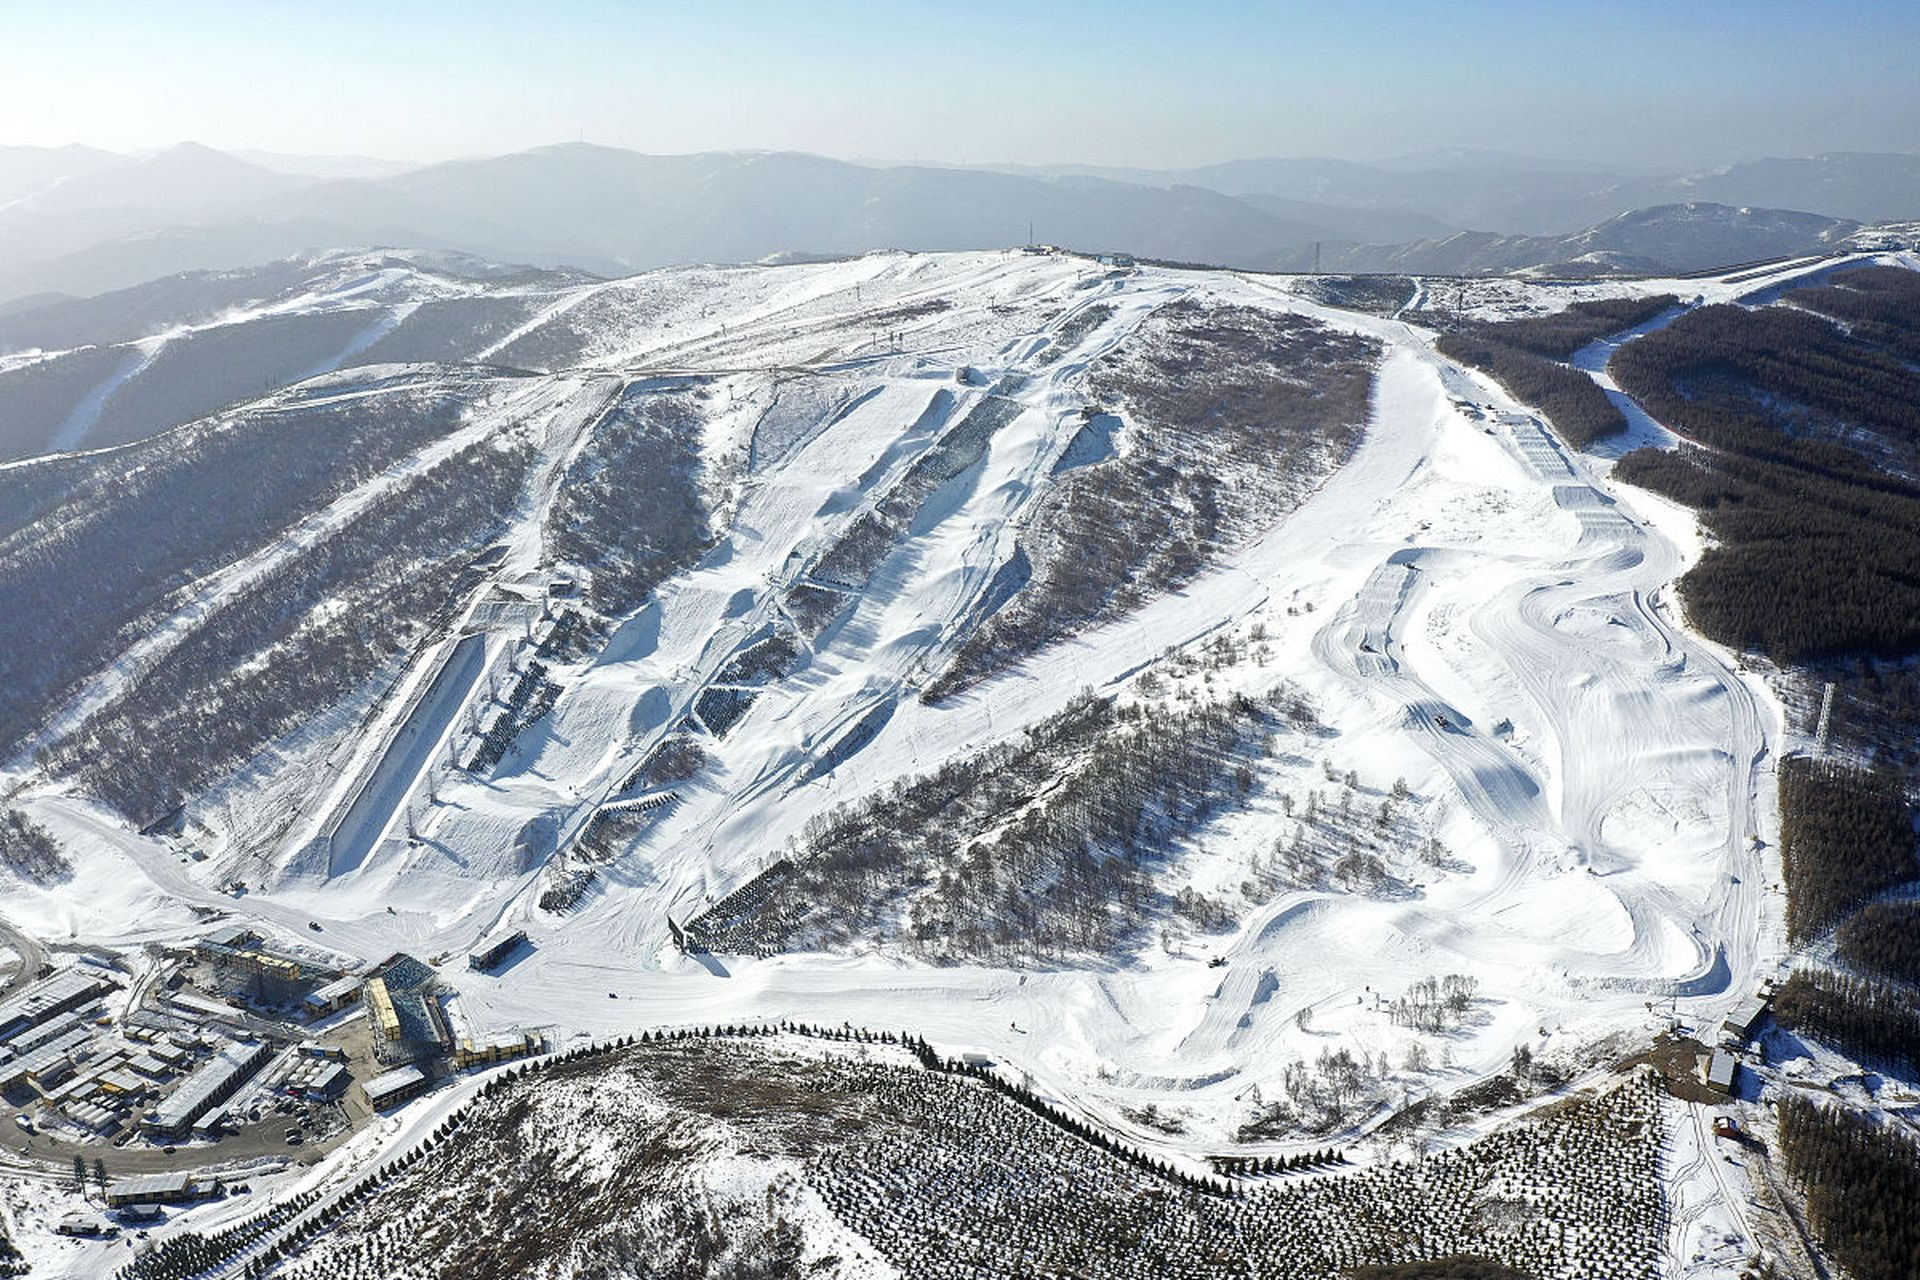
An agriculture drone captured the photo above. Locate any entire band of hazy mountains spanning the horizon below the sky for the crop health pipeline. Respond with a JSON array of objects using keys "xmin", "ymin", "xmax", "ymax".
[{"xmin": 0, "ymin": 144, "xmax": 1920, "ymax": 301}]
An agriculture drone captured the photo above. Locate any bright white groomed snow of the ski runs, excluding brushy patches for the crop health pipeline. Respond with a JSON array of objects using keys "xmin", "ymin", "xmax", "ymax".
[{"xmin": 6, "ymin": 245, "xmax": 1873, "ymax": 1274}]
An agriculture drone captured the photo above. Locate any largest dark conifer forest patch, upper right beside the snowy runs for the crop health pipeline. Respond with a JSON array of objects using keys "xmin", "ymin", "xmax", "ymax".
[{"xmin": 1611, "ymin": 267, "xmax": 1920, "ymax": 662}]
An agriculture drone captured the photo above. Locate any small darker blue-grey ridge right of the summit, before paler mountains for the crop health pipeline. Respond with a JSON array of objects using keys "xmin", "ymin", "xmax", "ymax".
[{"xmin": 1323, "ymin": 203, "xmax": 1860, "ymax": 276}]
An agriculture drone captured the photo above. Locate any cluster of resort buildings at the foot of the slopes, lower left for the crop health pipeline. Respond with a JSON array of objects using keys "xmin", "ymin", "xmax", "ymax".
[{"xmin": 0, "ymin": 927, "xmax": 545, "ymax": 1209}]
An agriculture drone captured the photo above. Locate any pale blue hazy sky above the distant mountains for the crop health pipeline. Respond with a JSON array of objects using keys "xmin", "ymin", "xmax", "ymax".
[{"xmin": 0, "ymin": 0, "xmax": 1920, "ymax": 167}]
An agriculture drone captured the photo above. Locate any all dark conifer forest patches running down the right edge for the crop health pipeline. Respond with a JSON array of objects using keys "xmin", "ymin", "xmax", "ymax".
[{"xmin": 1611, "ymin": 267, "xmax": 1920, "ymax": 1280}]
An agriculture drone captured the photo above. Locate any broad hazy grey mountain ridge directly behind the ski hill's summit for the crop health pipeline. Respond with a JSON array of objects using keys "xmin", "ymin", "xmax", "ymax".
[{"xmin": 278, "ymin": 144, "xmax": 1329, "ymax": 271}]
